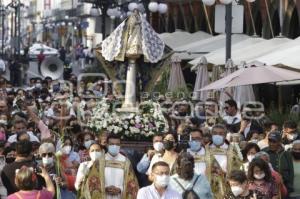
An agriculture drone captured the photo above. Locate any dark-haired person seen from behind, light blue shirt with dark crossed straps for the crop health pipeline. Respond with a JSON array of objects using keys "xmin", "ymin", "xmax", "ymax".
[{"xmin": 170, "ymin": 152, "xmax": 212, "ymax": 199}]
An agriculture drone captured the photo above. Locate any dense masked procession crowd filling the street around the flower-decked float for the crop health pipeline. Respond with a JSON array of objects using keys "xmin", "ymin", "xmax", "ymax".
[{"xmin": 0, "ymin": 75, "xmax": 300, "ymax": 199}]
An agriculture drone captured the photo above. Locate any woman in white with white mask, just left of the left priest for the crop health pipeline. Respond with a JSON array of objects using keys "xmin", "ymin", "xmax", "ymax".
[{"xmin": 75, "ymin": 143, "xmax": 102, "ymax": 190}]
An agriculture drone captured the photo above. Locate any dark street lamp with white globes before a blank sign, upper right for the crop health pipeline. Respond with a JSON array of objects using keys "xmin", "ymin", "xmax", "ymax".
[{"xmin": 202, "ymin": 0, "xmax": 255, "ymax": 62}]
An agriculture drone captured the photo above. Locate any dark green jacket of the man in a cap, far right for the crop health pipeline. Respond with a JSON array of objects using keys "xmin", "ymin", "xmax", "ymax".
[{"xmin": 263, "ymin": 147, "xmax": 294, "ymax": 193}]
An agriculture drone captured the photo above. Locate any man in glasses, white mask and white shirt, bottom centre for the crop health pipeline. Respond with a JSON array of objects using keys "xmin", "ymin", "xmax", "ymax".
[{"xmin": 137, "ymin": 161, "xmax": 182, "ymax": 199}]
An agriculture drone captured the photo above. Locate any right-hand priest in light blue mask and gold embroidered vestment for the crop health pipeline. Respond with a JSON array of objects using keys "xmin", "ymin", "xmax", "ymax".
[{"xmin": 206, "ymin": 124, "xmax": 242, "ymax": 199}]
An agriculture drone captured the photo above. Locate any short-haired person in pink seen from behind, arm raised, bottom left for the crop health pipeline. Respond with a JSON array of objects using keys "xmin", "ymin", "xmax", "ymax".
[{"xmin": 7, "ymin": 166, "xmax": 55, "ymax": 199}]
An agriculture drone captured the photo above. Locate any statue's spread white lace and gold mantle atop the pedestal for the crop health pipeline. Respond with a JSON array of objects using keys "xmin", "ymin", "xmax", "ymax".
[{"xmin": 102, "ymin": 10, "xmax": 165, "ymax": 63}]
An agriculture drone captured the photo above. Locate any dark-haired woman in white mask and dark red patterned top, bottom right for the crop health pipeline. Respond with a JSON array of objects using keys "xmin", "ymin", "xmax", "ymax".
[{"xmin": 248, "ymin": 158, "xmax": 279, "ymax": 199}]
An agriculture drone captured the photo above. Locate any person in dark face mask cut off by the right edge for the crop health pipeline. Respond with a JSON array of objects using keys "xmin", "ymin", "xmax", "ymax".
[{"xmin": 290, "ymin": 140, "xmax": 300, "ymax": 199}]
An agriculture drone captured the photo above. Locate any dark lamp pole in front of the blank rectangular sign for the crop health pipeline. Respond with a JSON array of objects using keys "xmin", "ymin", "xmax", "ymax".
[{"xmin": 225, "ymin": 3, "xmax": 232, "ymax": 62}]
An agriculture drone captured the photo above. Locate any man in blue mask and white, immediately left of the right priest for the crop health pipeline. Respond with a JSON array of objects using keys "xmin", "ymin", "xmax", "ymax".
[{"xmin": 187, "ymin": 129, "xmax": 208, "ymax": 175}]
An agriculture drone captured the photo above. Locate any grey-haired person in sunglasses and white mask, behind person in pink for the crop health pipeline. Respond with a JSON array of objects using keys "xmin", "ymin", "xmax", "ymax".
[{"xmin": 39, "ymin": 142, "xmax": 76, "ymax": 199}]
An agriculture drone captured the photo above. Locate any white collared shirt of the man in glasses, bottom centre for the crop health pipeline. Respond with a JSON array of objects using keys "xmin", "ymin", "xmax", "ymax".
[{"xmin": 137, "ymin": 184, "xmax": 182, "ymax": 199}]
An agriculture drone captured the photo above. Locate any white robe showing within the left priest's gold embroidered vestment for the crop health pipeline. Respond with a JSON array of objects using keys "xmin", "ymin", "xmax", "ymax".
[{"xmin": 104, "ymin": 153, "xmax": 126, "ymax": 199}]
